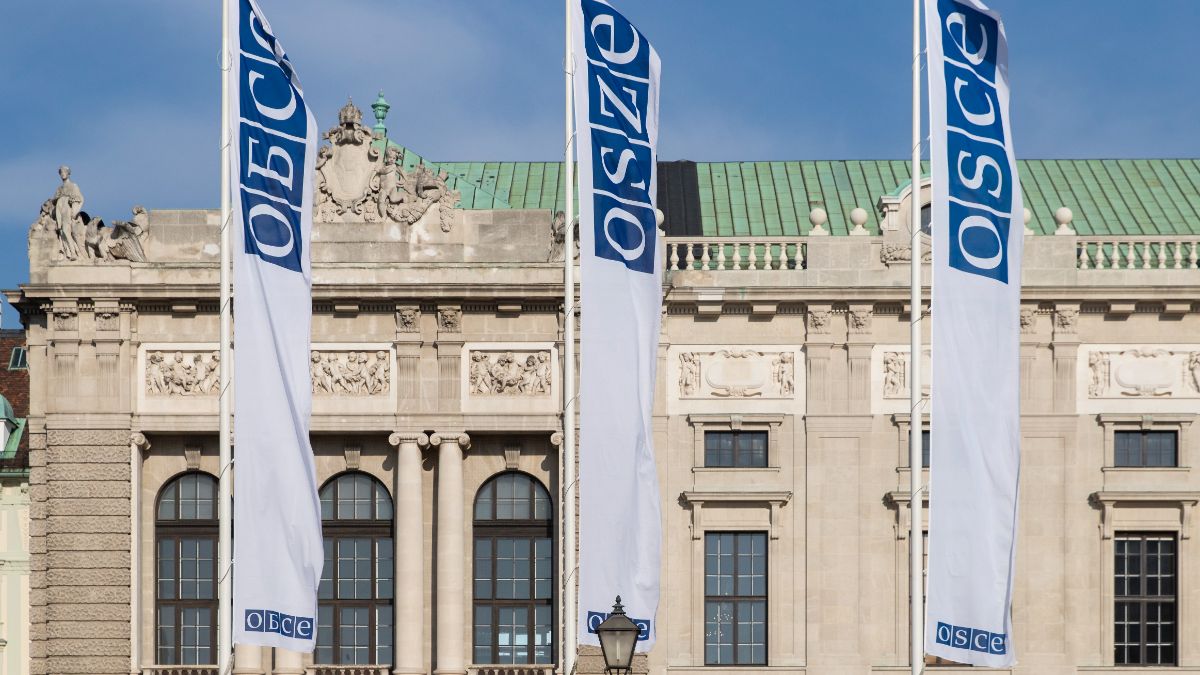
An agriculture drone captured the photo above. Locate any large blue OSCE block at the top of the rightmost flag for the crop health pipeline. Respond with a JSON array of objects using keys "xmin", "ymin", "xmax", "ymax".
[{"xmin": 937, "ymin": 0, "xmax": 1014, "ymax": 283}]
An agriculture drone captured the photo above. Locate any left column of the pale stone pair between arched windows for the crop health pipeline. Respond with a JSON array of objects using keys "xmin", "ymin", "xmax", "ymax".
[{"xmin": 388, "ymin": 431, "xmax": 432, "ymax": 675}]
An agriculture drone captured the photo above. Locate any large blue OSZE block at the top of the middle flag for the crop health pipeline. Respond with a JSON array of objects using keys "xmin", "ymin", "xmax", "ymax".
[{"xmin": 580, "ymin": 0, "xmax": 658, "ymax": 274}]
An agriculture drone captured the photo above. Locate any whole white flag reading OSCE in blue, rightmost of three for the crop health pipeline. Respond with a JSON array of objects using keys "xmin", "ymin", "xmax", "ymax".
[{"xmin": 925, "ymin": 0, "xmax": 1025, "ymax": 667}]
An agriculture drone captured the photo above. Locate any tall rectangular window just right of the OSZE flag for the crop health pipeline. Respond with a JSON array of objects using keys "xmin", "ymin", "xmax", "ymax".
[{"xmin": 704, "ymin": 532, "xmax": 767, "ymax": 665}]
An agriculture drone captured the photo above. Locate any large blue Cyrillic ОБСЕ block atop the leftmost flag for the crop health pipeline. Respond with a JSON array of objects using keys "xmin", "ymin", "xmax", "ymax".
[{"xmin": 236, "ymin": 0, "xmax": 310, "ymax": 271}]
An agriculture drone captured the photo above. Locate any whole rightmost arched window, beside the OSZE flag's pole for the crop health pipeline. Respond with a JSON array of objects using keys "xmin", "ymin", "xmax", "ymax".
[{"xmin": 474, "ymin": 472, "xmax": 554, "ymax": 664}]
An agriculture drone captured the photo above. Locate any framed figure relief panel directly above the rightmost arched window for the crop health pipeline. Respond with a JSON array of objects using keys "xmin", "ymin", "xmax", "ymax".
[{"xmin": 461, "ymin": 342, "xmax": 562, "ymax": 414}]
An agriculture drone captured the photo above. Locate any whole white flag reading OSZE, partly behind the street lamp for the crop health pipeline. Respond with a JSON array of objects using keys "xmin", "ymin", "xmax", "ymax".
[{"xmin": 571, "ymin": 0, "xmax": 662, "ymax": 651}]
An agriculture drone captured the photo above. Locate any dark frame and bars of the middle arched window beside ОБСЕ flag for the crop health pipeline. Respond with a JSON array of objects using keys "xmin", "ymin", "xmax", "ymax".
[{"xmin": 313, "ymin": 470, "xmax": 396, "ymax": 665}]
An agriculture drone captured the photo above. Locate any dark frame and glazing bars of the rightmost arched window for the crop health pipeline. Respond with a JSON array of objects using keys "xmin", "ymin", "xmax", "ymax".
[{"xmin": 470, "ymin": 471, "xmax": 559, "ymax": 667}]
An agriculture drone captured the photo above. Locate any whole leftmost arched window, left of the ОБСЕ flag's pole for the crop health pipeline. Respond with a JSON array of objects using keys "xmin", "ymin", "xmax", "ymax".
[{"xmin": 155, "ymin": 472, "xmax": 217, "ymax": 665}]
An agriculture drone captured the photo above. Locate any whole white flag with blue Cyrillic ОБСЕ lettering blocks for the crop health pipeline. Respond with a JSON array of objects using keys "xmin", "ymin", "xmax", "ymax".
[{"xmin": 222, "ymin": 0, "xmax": 324, "ymax": 652}]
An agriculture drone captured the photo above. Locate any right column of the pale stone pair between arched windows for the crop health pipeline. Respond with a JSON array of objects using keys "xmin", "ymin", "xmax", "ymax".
[{"xmin": 430, "ymin": 434, "xmax": 470, "ymax": 675}]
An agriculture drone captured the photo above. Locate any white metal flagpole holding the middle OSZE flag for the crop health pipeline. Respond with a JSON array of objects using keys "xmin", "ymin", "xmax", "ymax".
[{"xmin": 562, "ymin": 0, "xmax": 578, "ymax": 675}]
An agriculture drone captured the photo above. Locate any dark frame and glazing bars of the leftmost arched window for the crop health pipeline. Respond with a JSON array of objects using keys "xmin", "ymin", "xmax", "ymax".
[{"xmin": 154, "ymin": 471, "xmax": 220, "ymax": 665}]
